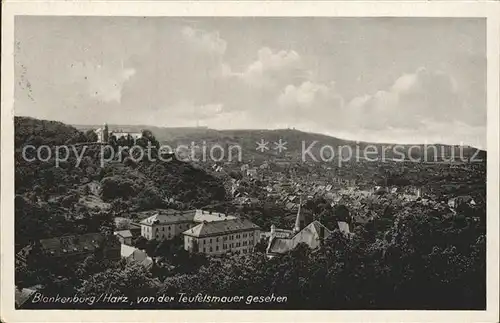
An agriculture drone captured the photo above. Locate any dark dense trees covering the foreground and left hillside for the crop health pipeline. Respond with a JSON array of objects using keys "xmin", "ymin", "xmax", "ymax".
[{"xmin": 15, "ymin": 118, "xmax": 486, "ymax": 309}]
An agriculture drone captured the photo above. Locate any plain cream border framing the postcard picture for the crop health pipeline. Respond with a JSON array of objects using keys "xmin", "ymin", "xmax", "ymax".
[{"xmin": 0, "ymin": 0, "xmax": 500, "ymax": 323}]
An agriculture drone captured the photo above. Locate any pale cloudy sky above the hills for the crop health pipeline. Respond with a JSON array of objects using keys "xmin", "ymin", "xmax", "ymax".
[{"xmin": 15, "ymin": 16, "xmax": 487, "ymax": 148}]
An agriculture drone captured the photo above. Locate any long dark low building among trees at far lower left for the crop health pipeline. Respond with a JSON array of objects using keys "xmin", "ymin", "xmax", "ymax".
[{"xmin": 16, "ymin": 233, "xmax": 120, "ymax": 265}]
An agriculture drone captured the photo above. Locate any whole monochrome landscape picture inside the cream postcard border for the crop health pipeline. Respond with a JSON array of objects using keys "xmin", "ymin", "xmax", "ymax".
[{"xmin": 2, "ymin": 1, "xmax": 498, "ymax": 320}]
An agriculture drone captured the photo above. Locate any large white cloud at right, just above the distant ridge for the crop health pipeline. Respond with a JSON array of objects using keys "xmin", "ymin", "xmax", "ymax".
[{"xmin": 348, "ymin": 68, "xmax": 475, "ymax": 129}]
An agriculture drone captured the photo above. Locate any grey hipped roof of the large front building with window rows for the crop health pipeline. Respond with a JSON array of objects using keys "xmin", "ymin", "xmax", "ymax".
[{"xmin": 182, "ymin": 219, "xmax": 260, "ymax": 237}]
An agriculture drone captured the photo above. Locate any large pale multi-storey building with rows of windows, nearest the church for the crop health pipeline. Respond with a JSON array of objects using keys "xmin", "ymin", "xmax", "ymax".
[{"xmin": 183, "ymin": 219, "xmax": 260, "ymax": 255}]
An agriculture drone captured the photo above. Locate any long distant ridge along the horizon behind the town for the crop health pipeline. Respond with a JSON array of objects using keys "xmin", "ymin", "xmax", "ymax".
[{"xmin": 76, "ymin": 125, "xmax": 486, "ymax": 162}]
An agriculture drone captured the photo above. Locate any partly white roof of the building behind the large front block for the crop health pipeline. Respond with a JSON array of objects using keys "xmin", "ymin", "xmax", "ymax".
[{"xmin": 140, "ymin": 209, "xmax": 236, "ymax": 225}]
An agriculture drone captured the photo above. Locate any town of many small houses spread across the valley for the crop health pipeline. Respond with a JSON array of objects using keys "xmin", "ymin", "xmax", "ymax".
[{"xmin": 16, "ymin": 121, "xmax": 485, "ymax": 306}]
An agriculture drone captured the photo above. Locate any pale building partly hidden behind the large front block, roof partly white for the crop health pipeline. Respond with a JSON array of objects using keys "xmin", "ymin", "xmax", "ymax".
[{"xmin": 140, "ymin": 209, "xmax": 236, "ymax": 240}]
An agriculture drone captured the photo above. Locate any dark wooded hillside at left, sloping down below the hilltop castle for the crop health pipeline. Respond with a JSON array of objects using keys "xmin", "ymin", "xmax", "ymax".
[{"xmin": 15, "ymin": 117, "xmax": 225, "ymax": 251}]
